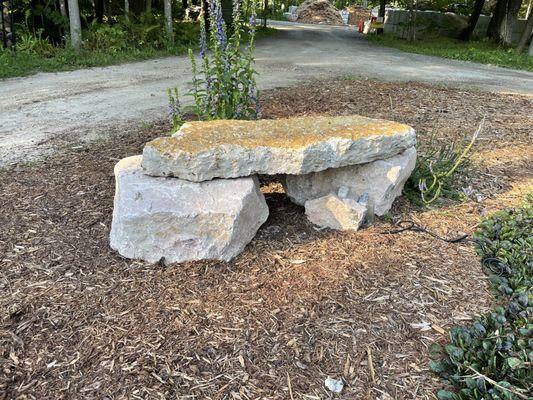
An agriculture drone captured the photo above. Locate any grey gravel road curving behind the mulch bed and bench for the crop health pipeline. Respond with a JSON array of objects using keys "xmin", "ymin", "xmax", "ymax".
[{"xmin": 0, "ymin": 23, "xmax": 533, "ymax": 166}]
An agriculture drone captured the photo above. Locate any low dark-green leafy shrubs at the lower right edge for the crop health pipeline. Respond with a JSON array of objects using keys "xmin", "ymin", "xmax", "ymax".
[{"xmin": 430, "ymin": 195, "xmax": 533, "ymax": 400}]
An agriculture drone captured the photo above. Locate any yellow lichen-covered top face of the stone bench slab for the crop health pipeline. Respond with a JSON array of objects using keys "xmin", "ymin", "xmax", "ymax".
[{"xmin": 148, "ymin": 116, "xmax": 411, "ymax": 154}]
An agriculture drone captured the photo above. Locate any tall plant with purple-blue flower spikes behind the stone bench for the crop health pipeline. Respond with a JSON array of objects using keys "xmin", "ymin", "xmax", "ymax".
[{"xmin": 168, "ymin": 0, "xmax": 259, "ymax": 127}]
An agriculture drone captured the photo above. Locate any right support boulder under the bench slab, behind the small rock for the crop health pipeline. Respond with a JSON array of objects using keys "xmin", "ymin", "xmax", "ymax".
[{"xmin": 283, "ymin": 147, "xmax": 416, "ymax": 215}]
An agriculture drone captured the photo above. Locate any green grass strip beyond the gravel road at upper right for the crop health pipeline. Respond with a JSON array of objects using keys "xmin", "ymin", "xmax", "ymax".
[{"xmin": 367, "ymin": 34, "xmax": 533, "ymax": 71}]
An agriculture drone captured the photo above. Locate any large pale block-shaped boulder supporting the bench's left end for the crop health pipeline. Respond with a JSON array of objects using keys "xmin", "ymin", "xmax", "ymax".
[{"xmin": 110, "ymin": 156, "xmax": 268, "ymax": 263}]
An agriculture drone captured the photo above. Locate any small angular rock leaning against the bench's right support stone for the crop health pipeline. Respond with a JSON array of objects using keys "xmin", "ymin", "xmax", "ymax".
[{"xmin": 305, "ymin": 194, "xmax": 366, "ymax": 231}]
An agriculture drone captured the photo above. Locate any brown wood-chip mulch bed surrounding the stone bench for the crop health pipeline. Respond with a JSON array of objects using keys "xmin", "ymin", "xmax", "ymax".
[{"xmin": 0, "ymin": 76, "xmax": 533, "ymax": 399}]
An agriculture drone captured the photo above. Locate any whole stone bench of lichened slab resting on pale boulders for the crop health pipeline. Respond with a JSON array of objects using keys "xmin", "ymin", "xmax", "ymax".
[{"xmin": 110, "ymin": 116, "xmax": 416, "ymax": 263}]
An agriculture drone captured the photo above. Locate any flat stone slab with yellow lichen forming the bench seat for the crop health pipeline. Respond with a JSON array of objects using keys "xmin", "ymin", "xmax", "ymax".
[{"xmin": 142, "ymin": 116, "xmax": 416, "ymax": 182}]
